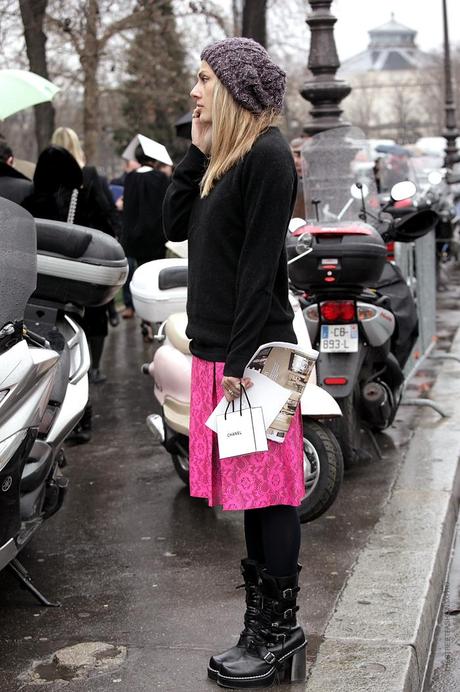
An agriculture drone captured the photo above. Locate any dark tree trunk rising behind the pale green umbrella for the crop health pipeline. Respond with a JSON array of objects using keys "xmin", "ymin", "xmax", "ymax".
[{"xmin": 19, "ymin": 0, "xmax": 54, "ymax": 151}]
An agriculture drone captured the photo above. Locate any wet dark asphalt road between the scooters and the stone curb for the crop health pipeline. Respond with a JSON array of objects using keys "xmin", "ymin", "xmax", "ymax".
[{"xmin": 0, "ymin": 272, "xmax": 458, "ymax": 692}]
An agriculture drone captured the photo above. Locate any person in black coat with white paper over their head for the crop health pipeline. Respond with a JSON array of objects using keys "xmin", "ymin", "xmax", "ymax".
[{"xmin": 122, "ymin": 144, "xmax": 170, "ymax": 332}]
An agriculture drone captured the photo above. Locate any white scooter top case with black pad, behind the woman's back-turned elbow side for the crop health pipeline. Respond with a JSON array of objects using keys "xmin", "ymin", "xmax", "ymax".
[{"xmin": 129, "ymin": 257, "xmax": 188, "ymax": 322}]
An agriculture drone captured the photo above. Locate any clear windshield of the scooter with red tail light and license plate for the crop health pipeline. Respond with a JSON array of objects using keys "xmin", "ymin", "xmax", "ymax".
[{"xmin": 302, "ymin": 127, "xmax": 379, "ymax": 225}]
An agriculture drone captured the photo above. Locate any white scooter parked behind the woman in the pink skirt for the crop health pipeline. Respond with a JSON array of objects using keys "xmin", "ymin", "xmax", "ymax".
[{"xmin": 130, "ymin": 258, "xmax": 343, "ymax": 522}]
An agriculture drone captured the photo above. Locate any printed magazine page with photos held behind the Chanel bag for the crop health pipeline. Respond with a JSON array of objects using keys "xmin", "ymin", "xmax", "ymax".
[{"xmin": 244, "ymin": 341, "xmax": 318, "ymax": 442}]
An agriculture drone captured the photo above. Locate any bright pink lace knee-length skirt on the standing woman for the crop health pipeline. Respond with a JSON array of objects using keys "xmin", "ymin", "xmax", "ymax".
[{"xmin": 190, "ymin": 356, "xmax": 305, "ymax": 510}]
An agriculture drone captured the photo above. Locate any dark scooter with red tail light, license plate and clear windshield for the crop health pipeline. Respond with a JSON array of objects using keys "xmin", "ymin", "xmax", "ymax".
[{"xmin": 287, "ymin": 128, "xmax": 438, "ymax": 467}]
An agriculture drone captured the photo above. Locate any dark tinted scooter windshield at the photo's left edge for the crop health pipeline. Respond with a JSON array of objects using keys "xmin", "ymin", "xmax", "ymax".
[{"xmin": 0, "ymin": 197, "xmax": 37, "ymax": 331}]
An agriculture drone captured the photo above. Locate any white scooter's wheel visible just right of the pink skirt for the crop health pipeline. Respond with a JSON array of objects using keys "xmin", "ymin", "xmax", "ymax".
[{"xmin": 298, "ymin": 418, "xmax": 343, "ymax": 524}]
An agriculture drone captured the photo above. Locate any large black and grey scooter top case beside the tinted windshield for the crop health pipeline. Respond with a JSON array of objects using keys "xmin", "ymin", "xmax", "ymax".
[{"xmin": 34, "ymin": 219, "xmax": 128, "ymax": 306}]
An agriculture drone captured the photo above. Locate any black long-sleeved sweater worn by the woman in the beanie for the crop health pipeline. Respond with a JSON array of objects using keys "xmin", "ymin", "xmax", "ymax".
[{"xmin": 163, "ymin": 127, "xmax": 297, "ymax": 377}]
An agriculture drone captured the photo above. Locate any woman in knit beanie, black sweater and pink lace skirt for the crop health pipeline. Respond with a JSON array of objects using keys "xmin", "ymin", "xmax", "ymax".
[{"xmin": 164, "ymin": 38, "xmax": 306, "ymax": 688}]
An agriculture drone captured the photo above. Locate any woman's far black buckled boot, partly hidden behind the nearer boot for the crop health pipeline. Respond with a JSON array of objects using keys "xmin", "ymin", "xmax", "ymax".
[{"xmin": 208, "ymin": 559, "xmax": 262, "ymax": 680}]
